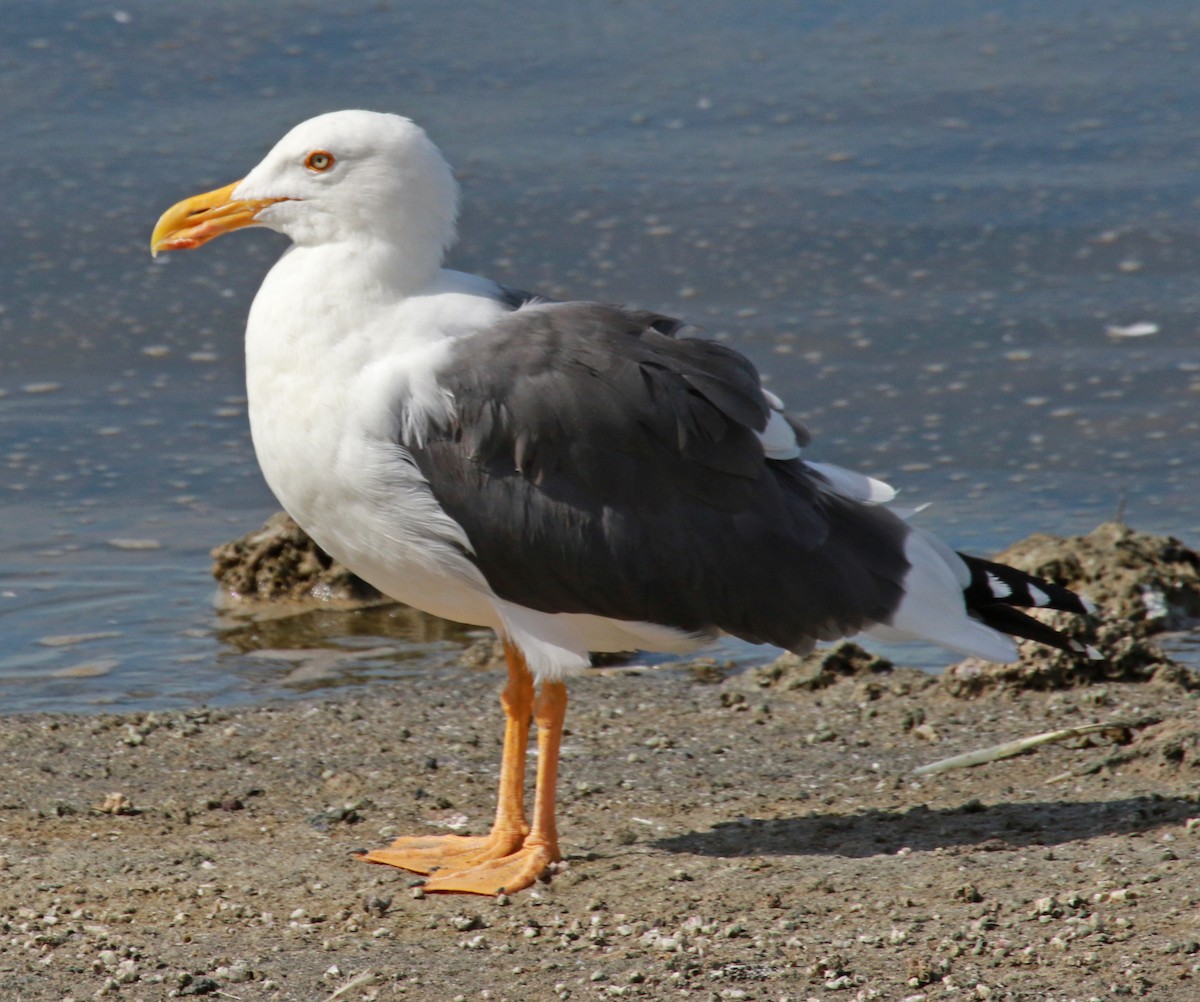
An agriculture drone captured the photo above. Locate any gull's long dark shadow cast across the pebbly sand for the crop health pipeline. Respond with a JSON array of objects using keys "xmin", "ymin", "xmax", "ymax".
[{"xmin": 654, "ymin": 794, "xmax": 1200, "ymax": 857}]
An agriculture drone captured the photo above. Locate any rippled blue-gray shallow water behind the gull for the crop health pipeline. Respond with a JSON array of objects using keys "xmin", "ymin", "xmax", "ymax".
[{"xmin": 0, "ymin": 0, "xmax": 1200, "ymax": 712}]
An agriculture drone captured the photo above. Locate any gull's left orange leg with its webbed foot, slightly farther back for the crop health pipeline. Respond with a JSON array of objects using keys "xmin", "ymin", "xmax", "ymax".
[{"xmin": 359, "ymin": 641, "xmax": 533, "ymax": 874}]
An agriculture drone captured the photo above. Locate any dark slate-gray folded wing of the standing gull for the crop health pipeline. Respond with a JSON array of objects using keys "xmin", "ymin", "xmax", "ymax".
[{"xmin": 412, "ymin": 302, "xmax": 907, "ymax": 648}]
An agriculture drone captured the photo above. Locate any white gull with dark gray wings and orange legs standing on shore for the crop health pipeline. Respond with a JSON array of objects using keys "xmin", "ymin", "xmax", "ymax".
[{"xmin": 151, "ymin": 110, "xmax": 1088, "ymax": 894}]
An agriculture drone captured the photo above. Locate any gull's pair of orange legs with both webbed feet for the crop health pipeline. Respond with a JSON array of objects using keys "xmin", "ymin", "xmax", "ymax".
[{"xmin": 361, "ymin": 641, "xmax": 566, "ymax": 894}]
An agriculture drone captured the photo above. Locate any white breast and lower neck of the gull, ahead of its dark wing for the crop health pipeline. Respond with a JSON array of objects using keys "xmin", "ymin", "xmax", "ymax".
[{"xmin": 246, "ymin": 248, "xmax": 503, "ymax": 626}]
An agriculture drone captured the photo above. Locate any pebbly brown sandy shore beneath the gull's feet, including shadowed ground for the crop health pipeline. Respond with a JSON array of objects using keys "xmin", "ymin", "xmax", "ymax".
[{"xmin": 0, "ymin": 520, "xmax": 1200, "ymax": 1002}]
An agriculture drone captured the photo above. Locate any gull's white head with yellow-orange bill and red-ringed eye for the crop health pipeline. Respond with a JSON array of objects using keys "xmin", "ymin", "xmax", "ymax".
[{"xmin": 150, "ymin": 112, "xmax": 458, "ymax": 262}]
